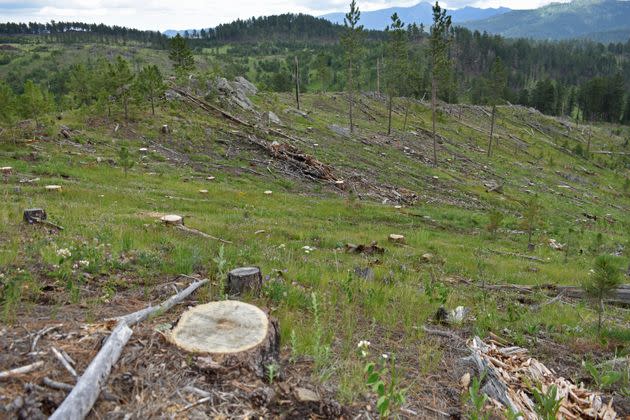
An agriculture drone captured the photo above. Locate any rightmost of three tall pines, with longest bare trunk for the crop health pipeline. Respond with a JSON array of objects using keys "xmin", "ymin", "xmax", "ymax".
[{"xmin": 430, "ymin": 1, "xmax": 451, "ymax": 166}]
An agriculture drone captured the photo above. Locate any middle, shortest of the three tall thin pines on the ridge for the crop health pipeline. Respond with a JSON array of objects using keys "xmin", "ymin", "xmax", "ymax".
[{"xmin": 385, "ymin": 13, "xmax": 409, "ymax": 136}]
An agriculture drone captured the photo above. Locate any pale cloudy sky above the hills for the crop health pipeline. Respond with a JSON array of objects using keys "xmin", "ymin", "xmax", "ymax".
[{"xmin": 0, "ymin": 0, "xmax": 568, "ymax": 31}]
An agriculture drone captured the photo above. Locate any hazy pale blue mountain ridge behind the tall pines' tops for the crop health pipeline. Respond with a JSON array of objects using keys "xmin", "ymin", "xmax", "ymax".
[{"xmin": 320, "ymin": 2, "xmax": 511, "ymax": 30}]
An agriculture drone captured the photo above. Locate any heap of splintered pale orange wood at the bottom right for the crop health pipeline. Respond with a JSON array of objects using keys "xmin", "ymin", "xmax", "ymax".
[{"xmin": 468, "ymin": 337, "xmax": 617, "ymax": 419}]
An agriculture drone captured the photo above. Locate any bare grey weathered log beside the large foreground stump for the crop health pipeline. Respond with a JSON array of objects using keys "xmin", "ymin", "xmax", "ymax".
[{"xmin": 50, "ymin": 279, "xmax": 208, "ymax": 420}]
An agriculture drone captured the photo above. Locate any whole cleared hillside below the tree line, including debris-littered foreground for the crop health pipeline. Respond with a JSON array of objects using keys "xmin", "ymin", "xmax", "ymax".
[{"xmin": 0, "ymin": 52, "xmax": 630, "ymax": 417}]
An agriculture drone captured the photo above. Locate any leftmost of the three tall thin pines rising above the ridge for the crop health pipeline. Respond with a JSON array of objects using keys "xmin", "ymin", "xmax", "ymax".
[{"xmin": 341, "ymin": 0, "xmax": 363, "ymax": 133}]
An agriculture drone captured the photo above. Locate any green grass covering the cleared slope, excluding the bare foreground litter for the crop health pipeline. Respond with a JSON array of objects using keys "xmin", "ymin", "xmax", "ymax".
[{"xmin": 0, "ymin": 67, "xmax": 630, "ymax": 412}]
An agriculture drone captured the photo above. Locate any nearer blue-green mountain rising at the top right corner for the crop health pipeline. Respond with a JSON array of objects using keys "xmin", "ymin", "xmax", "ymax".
[{"xmin": 462, "ymin": 0, "xmax": 630, "ymax": 42}]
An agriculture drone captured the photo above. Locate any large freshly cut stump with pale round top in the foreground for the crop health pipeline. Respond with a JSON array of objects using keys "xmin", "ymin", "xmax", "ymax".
[{"xmin": 168, "ymin": 300, "xmax": 280, "ymax": 377}]
